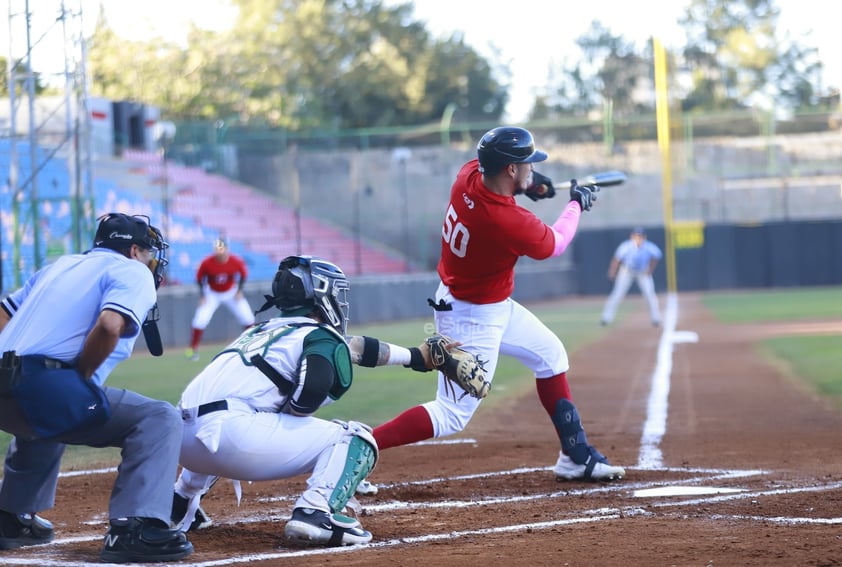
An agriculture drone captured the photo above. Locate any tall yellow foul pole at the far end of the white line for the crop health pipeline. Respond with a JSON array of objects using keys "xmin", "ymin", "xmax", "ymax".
[{"xmin": 652, "ymin": 38, "xmax": 678, "ymax": 292}]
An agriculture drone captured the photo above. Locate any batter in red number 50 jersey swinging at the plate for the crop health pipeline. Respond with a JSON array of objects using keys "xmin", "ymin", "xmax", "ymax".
[{"xmin": 374, "ymin": 127, "xmax": 625, "ymax": 480}]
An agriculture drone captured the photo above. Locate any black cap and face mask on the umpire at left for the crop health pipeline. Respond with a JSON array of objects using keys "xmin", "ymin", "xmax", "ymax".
[{"xmin": 94, "ymin": 213, "xmax": 170, "ymax": 289}]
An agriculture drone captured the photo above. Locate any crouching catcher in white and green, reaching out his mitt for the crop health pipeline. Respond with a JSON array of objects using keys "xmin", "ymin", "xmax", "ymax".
[{"xmin": 171, "ymin": 256, "xmax": 488, "ymax": 546}]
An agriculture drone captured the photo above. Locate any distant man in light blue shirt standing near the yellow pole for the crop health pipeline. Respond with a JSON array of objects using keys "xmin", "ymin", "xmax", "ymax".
[{"xmin": 601, "ymin": 227, "xmax": 663, "ymax": 327}]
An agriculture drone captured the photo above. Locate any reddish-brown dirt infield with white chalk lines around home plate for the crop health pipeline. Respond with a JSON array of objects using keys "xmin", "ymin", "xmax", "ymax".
[{"xmin": 0, "ymin": 295, "xmax": 842, "ymax": 567}]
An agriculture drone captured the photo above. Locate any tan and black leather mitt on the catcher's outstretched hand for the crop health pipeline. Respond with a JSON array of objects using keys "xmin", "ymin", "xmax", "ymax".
[{"xmin": 421, "ymin": 335, "xmax": 491, "ymax": 400}]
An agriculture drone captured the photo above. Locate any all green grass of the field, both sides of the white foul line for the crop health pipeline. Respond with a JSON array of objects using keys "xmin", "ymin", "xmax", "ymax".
[{"xmin": 0, "ymin": 288, "xmax": 842, "ymax": 469}]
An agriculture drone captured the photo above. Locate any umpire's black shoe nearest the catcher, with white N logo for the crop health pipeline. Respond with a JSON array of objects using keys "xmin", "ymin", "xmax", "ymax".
[{"xmin": 99, "ymin": 518, "xmax": 193, "ymax": 563}]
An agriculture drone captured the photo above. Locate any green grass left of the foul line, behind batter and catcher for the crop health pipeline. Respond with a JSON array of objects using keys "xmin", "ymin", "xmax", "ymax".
[{"xmin": 0, "ymin": 301, "xmax": 607, "ymax": 470}]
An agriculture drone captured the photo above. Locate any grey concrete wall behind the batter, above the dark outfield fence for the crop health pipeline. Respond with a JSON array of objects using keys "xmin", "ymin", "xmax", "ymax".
[{"xmin": 228, "ymin": 132, "xmax": 842, "ymax": 269}]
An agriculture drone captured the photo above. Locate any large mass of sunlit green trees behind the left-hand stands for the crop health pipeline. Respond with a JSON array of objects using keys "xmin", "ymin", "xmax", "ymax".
[{"xmin": 83, "ymin": 0, "xmax": 506, "ymax": 129}]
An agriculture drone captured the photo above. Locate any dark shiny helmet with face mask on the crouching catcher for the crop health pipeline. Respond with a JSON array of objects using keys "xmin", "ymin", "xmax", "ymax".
[{"xmin": 257, "ymin": 256, "xmax": 350, "ymax": 336}]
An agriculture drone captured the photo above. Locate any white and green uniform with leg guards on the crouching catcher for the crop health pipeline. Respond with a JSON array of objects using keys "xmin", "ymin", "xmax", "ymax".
[{"xmin": 175, "ymin": 317, "xmax": 377, "ymax": 536}]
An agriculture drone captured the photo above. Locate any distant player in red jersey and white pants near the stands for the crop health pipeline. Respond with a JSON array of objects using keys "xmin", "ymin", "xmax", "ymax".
[{"xmin": 186, "ymin": 238, "xmax": 254, "ymax": 360}]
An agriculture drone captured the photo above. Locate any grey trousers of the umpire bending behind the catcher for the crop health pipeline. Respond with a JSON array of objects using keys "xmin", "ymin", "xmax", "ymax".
[{"xmin": 0, "ymin": 387, "xmax": 182, "ymax": 524}]
